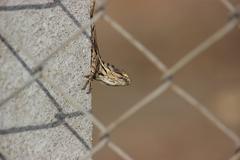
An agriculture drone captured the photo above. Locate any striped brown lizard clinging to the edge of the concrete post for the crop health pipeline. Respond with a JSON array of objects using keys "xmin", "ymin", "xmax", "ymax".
[{"xmin": 82, "ymin": 0, "xmax": 131, "ymax": 93}]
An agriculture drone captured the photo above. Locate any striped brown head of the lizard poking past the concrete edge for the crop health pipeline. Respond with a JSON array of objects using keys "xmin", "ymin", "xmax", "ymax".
[{"xmin": 97, "ymin": 63, "xmax": 131, "ymax": 86}]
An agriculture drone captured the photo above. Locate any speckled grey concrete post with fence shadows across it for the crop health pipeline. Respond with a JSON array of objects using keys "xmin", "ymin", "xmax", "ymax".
[{"xmin": 0, "ymin": 0, "xmax": 92, "ymax": 160}]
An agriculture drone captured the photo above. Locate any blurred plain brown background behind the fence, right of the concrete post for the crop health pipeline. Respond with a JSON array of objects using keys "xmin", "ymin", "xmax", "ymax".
[{"xmin": 93, "ymin": 0, "xmax": 240, "ymax": 160}]
